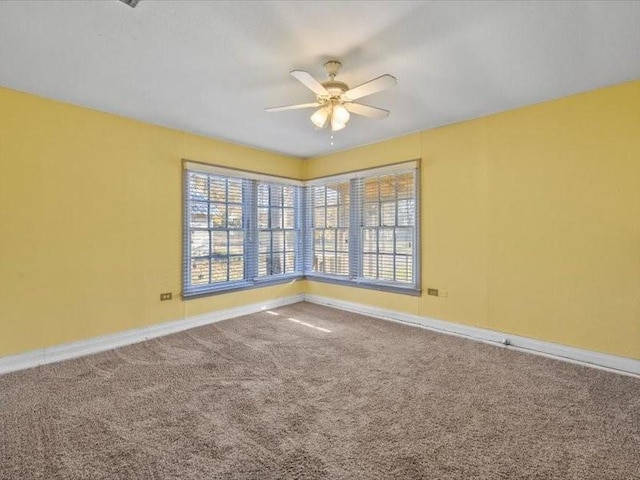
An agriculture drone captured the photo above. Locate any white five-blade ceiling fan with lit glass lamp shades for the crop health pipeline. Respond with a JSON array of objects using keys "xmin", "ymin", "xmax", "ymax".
[{"xmin": 265, "ymin": 60, "xmax": 398, "ymax": 132}]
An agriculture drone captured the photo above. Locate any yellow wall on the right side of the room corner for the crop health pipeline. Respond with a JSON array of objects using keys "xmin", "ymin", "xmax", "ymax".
[{"xmin": 304, "ymin": 81, "xmax": 640, "ymax": 359}]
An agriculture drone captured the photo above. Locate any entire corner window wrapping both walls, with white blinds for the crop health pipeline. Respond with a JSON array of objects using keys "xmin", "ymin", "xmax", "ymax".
[{"xmin": 183, "ymin": 161, "xmax": 420, "ymax": 297}]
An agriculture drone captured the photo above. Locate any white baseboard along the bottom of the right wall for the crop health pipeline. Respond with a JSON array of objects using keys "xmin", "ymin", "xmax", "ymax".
[{"xmin": 304, "ymin": 294, "xmax": 640, "ymax": 378}]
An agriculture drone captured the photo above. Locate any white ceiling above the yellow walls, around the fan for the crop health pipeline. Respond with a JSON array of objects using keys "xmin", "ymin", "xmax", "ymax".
[{"xmin": 0, "ymin": 0, "xmax": 640, "ymax": 157}]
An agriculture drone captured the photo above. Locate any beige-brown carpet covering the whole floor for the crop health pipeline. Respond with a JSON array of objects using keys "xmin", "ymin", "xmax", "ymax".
[{"xmin": 0, "ymin": 303, "xmax": 640, "ymax": 480}]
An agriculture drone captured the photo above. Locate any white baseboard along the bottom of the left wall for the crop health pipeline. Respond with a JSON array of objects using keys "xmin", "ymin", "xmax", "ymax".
[{"xmin": 0, "ymin": 294, "xmax": 304, "ymax": 375}]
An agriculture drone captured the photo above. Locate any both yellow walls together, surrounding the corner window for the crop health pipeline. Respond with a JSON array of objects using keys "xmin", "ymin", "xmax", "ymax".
[{"xmin": 0, "ymin": 81, "xmax": 640, "ymax": 359}]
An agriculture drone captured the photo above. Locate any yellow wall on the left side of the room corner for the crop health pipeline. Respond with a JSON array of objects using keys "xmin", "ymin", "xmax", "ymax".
[{"xmin": 0, "ymin": 88, "xmax": 302, "ymax": 357}]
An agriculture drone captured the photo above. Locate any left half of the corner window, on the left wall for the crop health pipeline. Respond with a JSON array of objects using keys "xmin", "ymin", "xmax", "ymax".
[{"xmin": 183, "ymin": 162, "xmax": 302, "ymax": 297}]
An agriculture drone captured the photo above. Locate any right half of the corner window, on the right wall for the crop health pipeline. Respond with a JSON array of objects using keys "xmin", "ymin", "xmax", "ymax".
[{"xmin": 305, "ymin": 162, "xmax": 419, "ymax": 294}]
